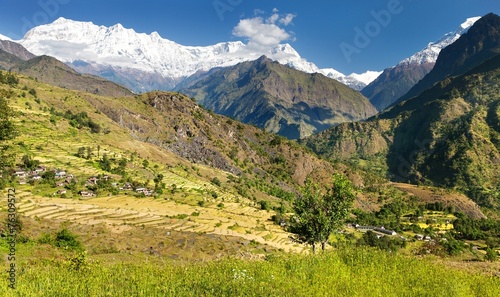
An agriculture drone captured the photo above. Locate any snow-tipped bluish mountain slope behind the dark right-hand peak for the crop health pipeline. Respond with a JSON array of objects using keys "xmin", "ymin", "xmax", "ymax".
[{"xmin": 361, "ymin": 17, "xmax": 479, "ymax": 111}]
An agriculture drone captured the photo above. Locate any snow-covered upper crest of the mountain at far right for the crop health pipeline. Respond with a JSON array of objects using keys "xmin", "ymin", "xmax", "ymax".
[{"xmin": 399, "ymin": 17, "xmax": 481, "ymax": 65}]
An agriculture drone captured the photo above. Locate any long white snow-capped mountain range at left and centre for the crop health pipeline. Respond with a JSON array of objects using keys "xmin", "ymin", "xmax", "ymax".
[{"xmin": 19, "ymin": 18, "xmax": 376, "ymax": 92}]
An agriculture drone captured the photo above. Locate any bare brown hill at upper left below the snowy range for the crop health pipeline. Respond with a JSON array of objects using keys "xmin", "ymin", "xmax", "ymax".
[{"xmin": 10, "ymin": 56, "xmax": 132, "ymax": 96}]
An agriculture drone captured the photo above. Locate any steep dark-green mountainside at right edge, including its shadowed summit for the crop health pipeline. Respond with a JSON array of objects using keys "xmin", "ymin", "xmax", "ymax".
[{"xmin": 305, "ymin": 15, "xmax": 500, "ymax": 207}]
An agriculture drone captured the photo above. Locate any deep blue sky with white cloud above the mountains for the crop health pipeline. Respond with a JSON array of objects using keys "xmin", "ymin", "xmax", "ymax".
[{"xmin": 0, "ymin": 0, "xmax": 500, "ymax": 74}]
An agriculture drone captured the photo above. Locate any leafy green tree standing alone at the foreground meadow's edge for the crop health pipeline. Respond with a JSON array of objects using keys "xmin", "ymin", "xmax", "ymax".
[{"xmin": 289, "ymin": 174, "xmax": 356, "ymax": 252}]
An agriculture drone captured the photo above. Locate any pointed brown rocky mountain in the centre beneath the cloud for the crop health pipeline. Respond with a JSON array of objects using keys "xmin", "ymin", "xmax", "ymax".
[{"xmin": 181, "ymin": 56, "xmax": 376, "ymax": 139}]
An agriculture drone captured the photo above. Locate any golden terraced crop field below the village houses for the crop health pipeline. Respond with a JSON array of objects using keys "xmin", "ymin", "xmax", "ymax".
[{"xmin": 9, "ymin": 192, "xmax": 304, "ymax": 252}]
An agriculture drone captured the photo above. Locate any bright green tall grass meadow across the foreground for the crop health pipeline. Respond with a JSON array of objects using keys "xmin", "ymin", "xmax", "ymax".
[{"xmin": 0, "ymin": 249, "xmax": 500, "ymax": 297}]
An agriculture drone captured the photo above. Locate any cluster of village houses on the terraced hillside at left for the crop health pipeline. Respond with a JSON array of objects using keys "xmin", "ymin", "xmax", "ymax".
[{"xmin": 14, "ymin": 166, "xmax": 154, "ymax": 198}]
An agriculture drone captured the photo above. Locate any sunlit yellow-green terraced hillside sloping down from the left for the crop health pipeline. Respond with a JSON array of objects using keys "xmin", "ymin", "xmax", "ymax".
[{"xmin": 0, "ymin": 70, "xmax": 352, "ymax": 251}]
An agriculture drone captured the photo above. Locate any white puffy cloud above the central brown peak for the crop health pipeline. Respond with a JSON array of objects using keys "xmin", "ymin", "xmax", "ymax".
[{"xmin": 233, "ymin": 8, "xmax": 295, "ymax": 50}]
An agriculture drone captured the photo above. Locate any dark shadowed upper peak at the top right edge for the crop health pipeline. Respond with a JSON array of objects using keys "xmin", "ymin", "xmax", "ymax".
[{"xmin": 396, "ymin": 13, "xmax": 500, "ymax": 103}]
